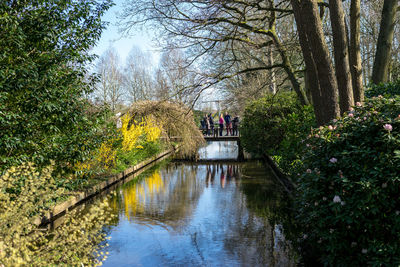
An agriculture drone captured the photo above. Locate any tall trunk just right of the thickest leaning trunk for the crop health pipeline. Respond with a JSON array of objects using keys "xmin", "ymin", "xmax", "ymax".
[{"xmin": 329, "ymin": 0, "xmax": 354, "ymax": 114}]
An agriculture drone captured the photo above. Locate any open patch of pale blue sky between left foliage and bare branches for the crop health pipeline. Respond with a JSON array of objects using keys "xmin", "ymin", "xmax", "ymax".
[{"xmin": 93, "ymin": 0, "xmax": 160, "ymax": 65}]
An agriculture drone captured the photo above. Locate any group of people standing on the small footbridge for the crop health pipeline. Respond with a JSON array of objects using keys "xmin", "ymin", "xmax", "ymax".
[{"xmin": 201, "ymin": 112, "xmax": 239, "ymax": 136}]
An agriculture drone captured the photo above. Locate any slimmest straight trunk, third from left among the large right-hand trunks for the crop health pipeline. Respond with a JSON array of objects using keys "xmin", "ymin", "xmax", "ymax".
[{"xmin": 349, "ymin": 0, "xmax": 364, "ymax": 102}]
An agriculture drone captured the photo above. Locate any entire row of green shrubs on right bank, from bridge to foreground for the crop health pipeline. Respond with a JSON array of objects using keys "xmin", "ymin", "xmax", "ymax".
[{"xmin": 241, "ymin": 83, "xmax": 400, "ymax": 266}]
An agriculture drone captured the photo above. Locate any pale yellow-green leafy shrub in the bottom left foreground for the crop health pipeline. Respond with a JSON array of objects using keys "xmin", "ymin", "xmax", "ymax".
[{"xmin": 0, "ymin": 164, "xmax": 114, "ymax": 266}]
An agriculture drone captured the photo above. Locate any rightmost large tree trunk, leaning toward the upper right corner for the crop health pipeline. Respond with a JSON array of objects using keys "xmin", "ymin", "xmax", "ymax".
[{"xmin": 371, "ymin": 0, "xmax": 398, "ymax": 84}]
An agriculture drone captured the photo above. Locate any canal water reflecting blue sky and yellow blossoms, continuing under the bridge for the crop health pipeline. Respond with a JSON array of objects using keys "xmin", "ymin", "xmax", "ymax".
[{"xmin": 98, "ymin": 142, "xmax": 296, "ymax": 266}]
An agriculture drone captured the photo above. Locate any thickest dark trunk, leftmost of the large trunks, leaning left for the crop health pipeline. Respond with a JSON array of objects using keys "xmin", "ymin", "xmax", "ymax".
[{"xmin": 291, "ymin": 0, "xmax": 339, "ymax": 124}]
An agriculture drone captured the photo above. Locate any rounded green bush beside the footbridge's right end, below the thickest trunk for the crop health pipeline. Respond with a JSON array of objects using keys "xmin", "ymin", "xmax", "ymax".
[{"xmin": 240, "ymin": 93, "xmax": 315, "ymax": 176}]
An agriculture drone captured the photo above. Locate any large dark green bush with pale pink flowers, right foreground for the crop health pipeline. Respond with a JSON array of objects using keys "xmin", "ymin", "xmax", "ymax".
[{"xmin": 295, "ymin": 97, "xmax": 400, "ymax": 266}]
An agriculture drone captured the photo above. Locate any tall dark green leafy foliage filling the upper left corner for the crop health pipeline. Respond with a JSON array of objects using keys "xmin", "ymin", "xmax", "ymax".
[{"xmin": 0, "ymin": 0, "xmax": 111, "ymax": 174}]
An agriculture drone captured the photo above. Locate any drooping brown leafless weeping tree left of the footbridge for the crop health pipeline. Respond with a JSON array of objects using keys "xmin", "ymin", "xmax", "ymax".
[{"xmin": 125, "ymin": 101, "xmax": 204, "ymax": 155}]
